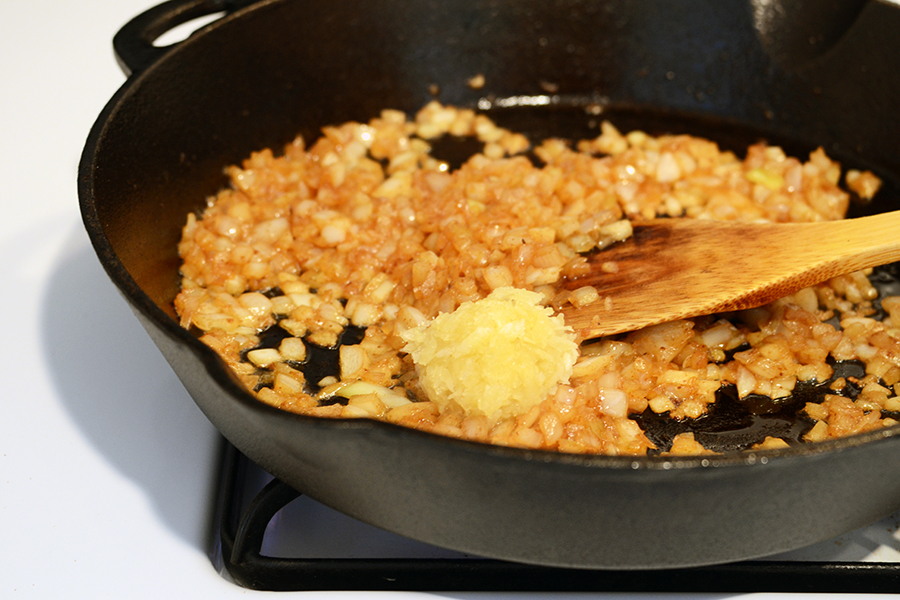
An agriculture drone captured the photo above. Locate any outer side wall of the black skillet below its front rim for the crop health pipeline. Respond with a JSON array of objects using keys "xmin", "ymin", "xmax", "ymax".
[{"xmin": 138, "ymin": 313, "xmax": 900, "ymax": 569}]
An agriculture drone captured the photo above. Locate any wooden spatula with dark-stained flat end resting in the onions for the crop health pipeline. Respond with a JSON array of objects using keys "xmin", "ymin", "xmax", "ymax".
[{"xmin": 561, "ymin": 211, "xmax": 900, "ymax": 339}]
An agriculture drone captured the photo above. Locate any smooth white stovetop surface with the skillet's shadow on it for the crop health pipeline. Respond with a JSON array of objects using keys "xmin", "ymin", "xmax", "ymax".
[{"xmin": 0, "ymin": 0, "xmax": 896, "ymax": 599}]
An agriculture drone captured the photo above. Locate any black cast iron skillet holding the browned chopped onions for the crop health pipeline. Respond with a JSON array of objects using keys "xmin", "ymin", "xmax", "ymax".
[{"xmin": 79, "ymin": 0, "xmax": 900, "ymax": 569}]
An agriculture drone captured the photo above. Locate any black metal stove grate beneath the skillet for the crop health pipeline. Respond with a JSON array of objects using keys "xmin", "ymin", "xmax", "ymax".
[{"xmin": 212, "ymin": 443, "xmax": 900, "ymax": 593}]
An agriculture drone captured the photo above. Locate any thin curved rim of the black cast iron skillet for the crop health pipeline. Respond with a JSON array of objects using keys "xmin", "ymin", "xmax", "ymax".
[{"xmin": 78, "ymin": 0, "xmax": 900, "ymax": 480}]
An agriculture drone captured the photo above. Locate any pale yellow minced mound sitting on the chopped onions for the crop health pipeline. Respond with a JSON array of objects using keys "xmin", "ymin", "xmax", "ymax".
[{"xmin": 403, "ymin": 287, "xmax": 578, "ymax": 420}]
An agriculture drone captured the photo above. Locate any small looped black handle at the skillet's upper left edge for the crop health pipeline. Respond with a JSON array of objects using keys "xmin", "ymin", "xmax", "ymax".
[{"xmin": 113, "ymin": 0, "xmax": 258, "ymax": 75}]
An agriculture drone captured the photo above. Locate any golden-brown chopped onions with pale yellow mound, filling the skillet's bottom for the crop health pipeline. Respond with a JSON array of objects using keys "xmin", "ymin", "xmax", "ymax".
[{"xmin": 176, "ymin": 102, "xmax": 900, "ymax": 454}]
